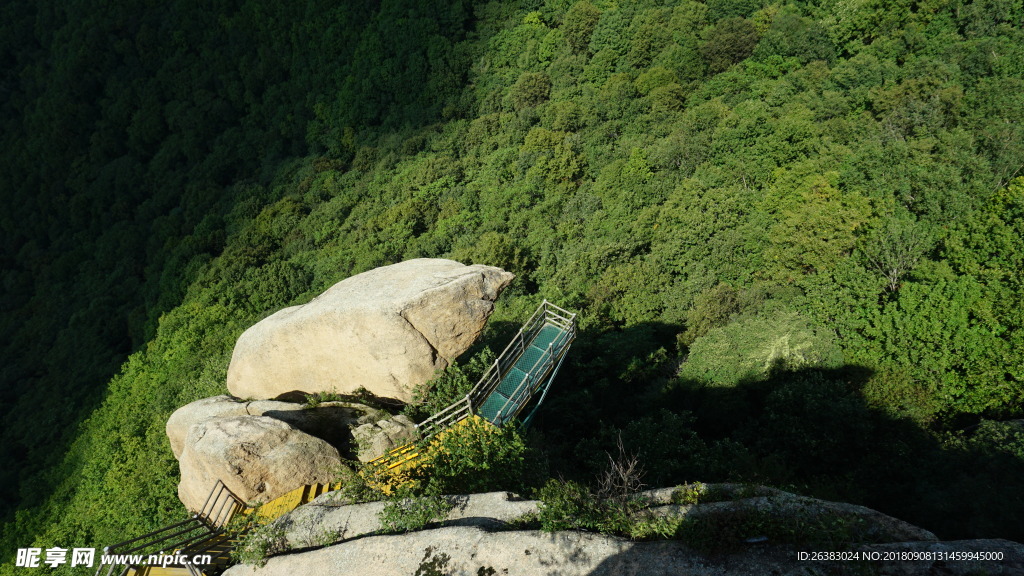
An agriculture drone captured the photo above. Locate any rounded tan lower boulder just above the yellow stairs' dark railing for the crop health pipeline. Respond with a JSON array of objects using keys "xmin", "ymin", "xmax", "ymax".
[{"xmin": 178, "ymin": 416, "xmax": 342, "ymax": 511}]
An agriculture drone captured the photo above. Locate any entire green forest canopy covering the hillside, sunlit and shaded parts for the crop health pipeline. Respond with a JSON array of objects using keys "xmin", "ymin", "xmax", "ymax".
[{"xmin": 0, "ymin": 0, "xmax": 1024, "ymax": 570}]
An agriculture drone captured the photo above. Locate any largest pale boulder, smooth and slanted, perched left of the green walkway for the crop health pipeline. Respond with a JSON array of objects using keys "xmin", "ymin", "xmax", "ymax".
[{"xmin": 227, "ymin": 258, "xmax": 514, "ymax": 402}]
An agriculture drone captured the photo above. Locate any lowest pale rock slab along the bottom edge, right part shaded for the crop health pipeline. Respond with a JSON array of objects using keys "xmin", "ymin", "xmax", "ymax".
[{"xmin": 224, "ymin": 527, "xmax": 1024, "ymax": 576}]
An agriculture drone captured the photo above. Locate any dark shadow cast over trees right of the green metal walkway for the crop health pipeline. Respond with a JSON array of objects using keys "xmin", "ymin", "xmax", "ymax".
[{"xmin": 491, "ymin": 323, "xmax": 1024, "ymax": 541}]
